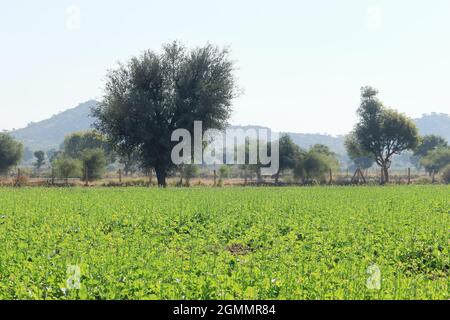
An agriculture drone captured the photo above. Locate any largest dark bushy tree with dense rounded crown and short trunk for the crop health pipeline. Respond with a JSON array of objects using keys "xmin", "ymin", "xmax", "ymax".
[{"xmin": 93, "ymin": 42, "xmax": 237, "ymax": 186}]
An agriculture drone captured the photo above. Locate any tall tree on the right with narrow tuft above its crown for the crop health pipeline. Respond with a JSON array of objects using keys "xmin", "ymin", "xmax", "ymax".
[{"xmin": 352, "ymin": 87, "xmax": 419, "ymax": 183}]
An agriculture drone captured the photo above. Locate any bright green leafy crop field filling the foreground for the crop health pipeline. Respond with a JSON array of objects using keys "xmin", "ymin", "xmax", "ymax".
[{"xmin": 0, "ymin": 186, "xmax": 450, "ymax": 299}]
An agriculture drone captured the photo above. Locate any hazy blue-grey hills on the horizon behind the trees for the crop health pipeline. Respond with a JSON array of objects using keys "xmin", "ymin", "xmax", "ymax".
[{"xmin": 7, "ymin": 100, "xmax": 450, "ymax": 156}]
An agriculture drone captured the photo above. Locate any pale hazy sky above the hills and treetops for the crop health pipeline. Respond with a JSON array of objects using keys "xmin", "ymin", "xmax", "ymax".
[{"xmin": 0, "ymin": 0, "xmax": 450, "ymax": 134}]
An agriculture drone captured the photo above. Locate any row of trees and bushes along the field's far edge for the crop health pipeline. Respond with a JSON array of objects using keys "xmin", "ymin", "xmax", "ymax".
[{"xmin": 0, "ymin": 42, "xmax": 450, "ymax": 186}]
